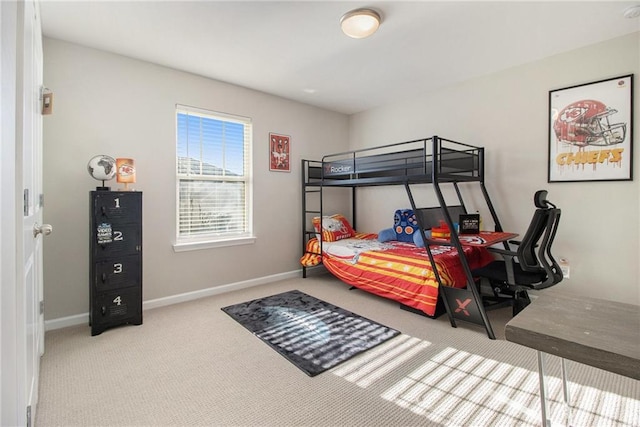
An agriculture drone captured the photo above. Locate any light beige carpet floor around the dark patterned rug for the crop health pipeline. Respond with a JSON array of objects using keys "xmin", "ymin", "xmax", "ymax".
[{"xmin": 35, "ymin": 275, "xmax": 640, "ymax": 427}]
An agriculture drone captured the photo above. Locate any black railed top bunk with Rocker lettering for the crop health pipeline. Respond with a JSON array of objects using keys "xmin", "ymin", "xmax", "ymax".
[{"xmin": 303, "ymin": 136, "xmax": 484, "ymax": 187}]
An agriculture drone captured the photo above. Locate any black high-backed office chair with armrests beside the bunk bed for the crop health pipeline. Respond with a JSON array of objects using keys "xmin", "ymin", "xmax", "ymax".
[{"xmin": 471, "ymin": 190, "xmax": 562, "ymax": 316}]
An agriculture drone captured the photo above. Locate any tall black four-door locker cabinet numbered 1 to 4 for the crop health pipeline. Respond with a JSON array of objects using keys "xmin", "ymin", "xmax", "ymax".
[{"xmin": 89, "ymin": 191, "xmax": 142, "ymax": 335}]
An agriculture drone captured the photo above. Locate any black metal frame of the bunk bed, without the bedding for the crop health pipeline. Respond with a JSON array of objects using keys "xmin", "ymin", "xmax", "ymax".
[{"xmin": 302, "ymin": 136, "xmax": 506, "ymax": 339}]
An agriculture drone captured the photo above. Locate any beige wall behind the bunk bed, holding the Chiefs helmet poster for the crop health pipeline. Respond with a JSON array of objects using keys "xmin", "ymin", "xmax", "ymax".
[{"xmin": 350, "ymin": 33, "xmax": 640, "ymax": 304}]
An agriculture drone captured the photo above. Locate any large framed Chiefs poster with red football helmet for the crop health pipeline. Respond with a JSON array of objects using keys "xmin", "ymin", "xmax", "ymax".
[{"xmin": 548, "ymin": 74, "xmax": 633, "ymax": 182}]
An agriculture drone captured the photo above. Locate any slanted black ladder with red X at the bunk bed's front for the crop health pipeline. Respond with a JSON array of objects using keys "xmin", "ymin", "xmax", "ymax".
[{"xmin": 405, "ymin": 179, "xmax": 506, "ymax": 340}]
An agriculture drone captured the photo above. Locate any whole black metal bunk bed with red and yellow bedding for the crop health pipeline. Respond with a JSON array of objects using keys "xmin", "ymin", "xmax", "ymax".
[{"xmin": 301, "ymin": 136, "xmax": 506, "ymax": 339}]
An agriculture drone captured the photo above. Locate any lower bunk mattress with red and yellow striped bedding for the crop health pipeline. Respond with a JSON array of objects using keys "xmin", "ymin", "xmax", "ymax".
[{"xmin": 300, "ymin": 232, "xmax": 493, "ymax": 317}]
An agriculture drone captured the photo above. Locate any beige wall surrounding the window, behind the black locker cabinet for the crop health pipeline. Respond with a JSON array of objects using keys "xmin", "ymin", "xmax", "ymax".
[{"xmin": 44, "ymin": 39, "xmax": 348, "ymax": 320}]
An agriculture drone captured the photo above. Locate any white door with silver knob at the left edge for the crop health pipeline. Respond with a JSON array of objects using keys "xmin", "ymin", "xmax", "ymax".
[{"xmin": 0, "ymin": 0, "xmax": 47, "ymax": 426}]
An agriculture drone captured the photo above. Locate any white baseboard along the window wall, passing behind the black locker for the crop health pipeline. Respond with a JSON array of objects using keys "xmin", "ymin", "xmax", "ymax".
[{"xmin": 44, "ymin": 270, "xmax": 302, "ymax": 331}]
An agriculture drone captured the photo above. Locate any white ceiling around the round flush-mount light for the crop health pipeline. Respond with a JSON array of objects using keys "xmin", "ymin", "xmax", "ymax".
[{"xmin": 41, "ymin": 0, "xmax": 640, "ymax": 114}]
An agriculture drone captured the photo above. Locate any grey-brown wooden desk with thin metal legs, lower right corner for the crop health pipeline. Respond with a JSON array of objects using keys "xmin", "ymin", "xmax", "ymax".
[{"xmin": 505, "ymin": 291, "xmax": 640, "ymax": 426}]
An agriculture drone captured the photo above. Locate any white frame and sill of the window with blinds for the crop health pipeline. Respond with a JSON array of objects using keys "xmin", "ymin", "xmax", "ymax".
[{"xmin": 173, "ymin": 104, "xmax": 256, "ymax": 252}]
